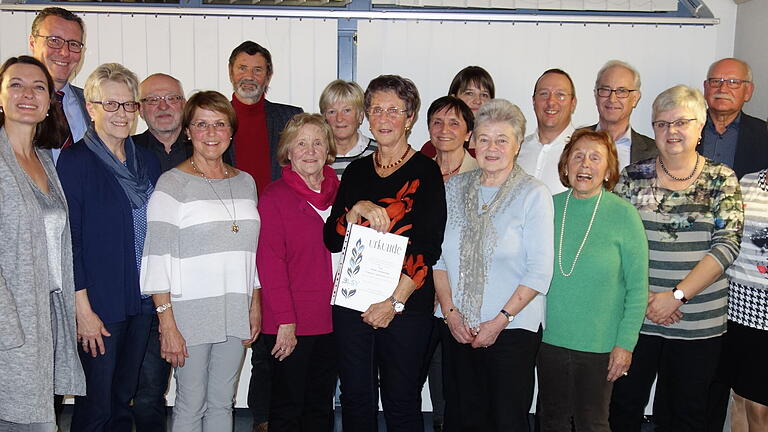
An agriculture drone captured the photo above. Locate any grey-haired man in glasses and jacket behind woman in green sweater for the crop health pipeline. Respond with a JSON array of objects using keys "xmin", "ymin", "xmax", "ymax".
[{"xmin": 590, "ymin": 60, "xmax": 658, "ymax": 170}]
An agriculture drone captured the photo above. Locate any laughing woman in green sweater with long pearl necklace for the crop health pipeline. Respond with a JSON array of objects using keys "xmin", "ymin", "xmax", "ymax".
[{"xmin": 537, "ymin": 129, "xmax": 648, "ymax": 432}]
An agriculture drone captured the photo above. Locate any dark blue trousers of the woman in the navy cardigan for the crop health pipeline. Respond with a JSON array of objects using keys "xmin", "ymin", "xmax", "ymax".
[{"xmin": 71, "ymin": 299, "xmax": 155, "ymax": 432}]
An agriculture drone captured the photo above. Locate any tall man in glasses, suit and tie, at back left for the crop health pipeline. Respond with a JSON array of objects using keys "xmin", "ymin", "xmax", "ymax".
[{"xmin": 29, "ymin": 7, "xmax": 89, "ymax": 161}]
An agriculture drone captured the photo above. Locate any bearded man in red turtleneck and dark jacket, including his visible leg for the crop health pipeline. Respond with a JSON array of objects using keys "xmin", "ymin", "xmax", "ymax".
[{"xmin": 228, "ymin": 41, "xmax": 302, "ymax": 432}]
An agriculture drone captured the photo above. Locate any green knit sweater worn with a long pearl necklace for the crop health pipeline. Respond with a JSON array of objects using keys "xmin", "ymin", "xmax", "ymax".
[{"xmin": 544, "ymin": 191, "xmax": 648, "ymax": 353}]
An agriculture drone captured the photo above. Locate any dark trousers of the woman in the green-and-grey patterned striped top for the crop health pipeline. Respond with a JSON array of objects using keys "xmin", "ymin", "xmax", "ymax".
[{"xmin": 610, "ymin": 334, "xmax": 723, "ymax": 432}]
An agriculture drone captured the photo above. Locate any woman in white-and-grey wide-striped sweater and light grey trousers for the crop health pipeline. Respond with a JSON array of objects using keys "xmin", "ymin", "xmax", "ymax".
[{"xmin": 141, "ymin": 91, "xmax": 261, "ymax": 432}]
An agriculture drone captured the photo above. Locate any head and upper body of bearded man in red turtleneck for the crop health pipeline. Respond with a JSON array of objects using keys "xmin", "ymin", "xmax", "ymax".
[{"xmin": 229, "ymin": 41, "xmax": 302, "ymax": 194}]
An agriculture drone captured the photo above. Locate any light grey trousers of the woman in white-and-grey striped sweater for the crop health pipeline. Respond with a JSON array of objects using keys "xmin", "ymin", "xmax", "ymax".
[{"xmin": 171, "ymin": 337, "xmax": 245, "ymax": 432}]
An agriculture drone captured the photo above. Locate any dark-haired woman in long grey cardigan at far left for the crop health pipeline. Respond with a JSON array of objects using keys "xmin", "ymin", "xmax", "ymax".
[{"xmin": 0, "ymin": 56, "xmax": 85, "ymax": 431}]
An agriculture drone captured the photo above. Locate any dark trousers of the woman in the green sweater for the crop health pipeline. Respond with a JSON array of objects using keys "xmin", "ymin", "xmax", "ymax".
[{"xmin": 536, "ymin": 343, "xmax": 613, "ymax": 432}]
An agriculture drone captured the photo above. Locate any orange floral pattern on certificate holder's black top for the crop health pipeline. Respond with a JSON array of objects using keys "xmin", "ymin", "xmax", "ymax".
[{"xmin": 336, "ymin": 179, "xmax": 429, "ymax": 289}]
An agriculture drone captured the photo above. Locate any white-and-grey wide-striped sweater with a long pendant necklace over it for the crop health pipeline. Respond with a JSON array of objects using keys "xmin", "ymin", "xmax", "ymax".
[{"xmin": 141, "ymin": 168, "xmax": 260, "ymax": 346}]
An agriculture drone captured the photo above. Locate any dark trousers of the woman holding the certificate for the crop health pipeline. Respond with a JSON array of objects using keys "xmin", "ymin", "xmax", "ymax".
[{"xmin": 333, "ymin": 306, "xmax": 432, "ymax": 432}]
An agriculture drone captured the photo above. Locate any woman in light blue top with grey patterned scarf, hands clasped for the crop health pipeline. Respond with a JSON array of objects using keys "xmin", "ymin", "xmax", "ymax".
[{"xmin": 434, "ymin": 99, "xmax": 554, "ymax": 432}]
